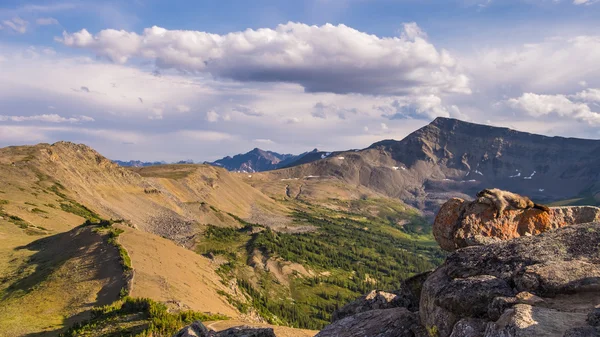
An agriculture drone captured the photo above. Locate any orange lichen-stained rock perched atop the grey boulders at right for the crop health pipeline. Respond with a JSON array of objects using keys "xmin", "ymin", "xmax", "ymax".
[{"xmin": 433, "ymin": 198, "xmax": 600, "ymax": 251}]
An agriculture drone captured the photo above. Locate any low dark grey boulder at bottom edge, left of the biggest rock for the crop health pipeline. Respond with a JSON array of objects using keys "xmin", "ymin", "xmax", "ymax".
[{"xmin": 315, "ymin": 308, "xmax": 427, "ymax": 337}]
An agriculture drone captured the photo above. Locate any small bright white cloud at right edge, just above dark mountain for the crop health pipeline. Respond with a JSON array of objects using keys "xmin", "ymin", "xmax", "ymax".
[{"xmin": 506, "ymin": 93, "xmax": 600, "ymax": 125}]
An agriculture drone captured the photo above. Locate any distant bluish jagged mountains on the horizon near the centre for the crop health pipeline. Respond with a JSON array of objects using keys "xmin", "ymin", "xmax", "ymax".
[{"xmin": 206, "ymin": 148, "xmax": 328, "ymax": 173}]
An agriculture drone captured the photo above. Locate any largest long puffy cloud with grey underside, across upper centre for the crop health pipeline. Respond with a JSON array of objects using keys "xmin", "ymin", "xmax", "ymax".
[{"xmin": 57, "ymin": 22, "xmax": 470, "ymax": 95}]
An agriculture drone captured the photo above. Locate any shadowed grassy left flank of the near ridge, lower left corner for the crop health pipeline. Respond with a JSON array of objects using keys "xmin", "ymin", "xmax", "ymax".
[{"xmin": 0, "ymin": 225, "xmax": 125, "ymax": 336}]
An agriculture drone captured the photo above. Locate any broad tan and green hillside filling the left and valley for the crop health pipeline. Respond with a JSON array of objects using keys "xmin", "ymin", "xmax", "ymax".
[{"xmin": 0, "ymin": 143, "xmax": 441, "ymax": 336}]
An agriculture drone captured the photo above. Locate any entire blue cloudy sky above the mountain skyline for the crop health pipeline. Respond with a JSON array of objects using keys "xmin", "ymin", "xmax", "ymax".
[{"xmin": 0, "ymin": 0, "xmax": 600, "ymax": 161}]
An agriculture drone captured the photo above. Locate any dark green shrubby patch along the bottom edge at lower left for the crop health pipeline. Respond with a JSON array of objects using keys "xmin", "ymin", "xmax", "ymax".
[{"xmin": 60, "ymin": 297, "xmax": 229, "ymax": 337}]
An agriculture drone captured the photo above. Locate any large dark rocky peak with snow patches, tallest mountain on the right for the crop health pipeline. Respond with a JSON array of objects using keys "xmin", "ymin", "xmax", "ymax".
[{"xmin": 254, "ymin": 118, "xmax": 600, "ymax": 215}]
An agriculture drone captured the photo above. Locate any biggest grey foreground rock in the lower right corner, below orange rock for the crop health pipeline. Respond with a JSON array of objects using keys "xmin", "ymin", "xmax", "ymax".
[{"xmin": 419, "ymin": 223, "xmax": 600, "ymax": 337}]
